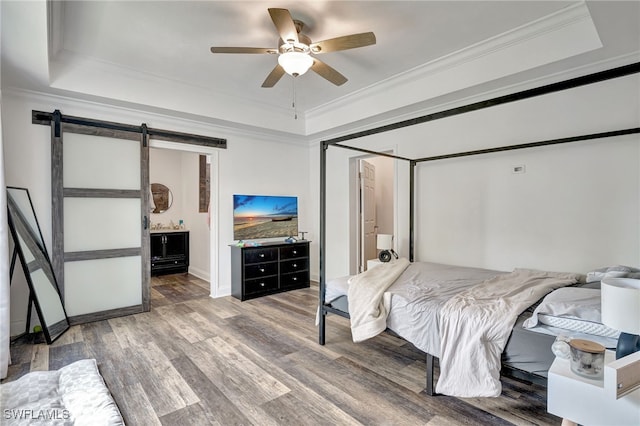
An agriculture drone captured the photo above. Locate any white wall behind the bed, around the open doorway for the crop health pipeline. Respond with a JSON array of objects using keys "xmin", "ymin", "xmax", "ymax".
[{"xmin": 312, "ymin": 75, "xmax": 640, "ymax": 278}]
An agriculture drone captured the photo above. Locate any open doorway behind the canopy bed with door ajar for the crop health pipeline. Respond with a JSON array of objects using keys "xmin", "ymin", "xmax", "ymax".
[{"xmin": 351, "ymin": 156, "xmax": 395, "ymax": 273}]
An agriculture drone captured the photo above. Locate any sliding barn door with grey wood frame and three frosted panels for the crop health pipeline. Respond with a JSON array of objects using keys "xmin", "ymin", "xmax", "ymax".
[{"xmin": 52, "ymin": 123, "xmax": 150, "ymax": 323}]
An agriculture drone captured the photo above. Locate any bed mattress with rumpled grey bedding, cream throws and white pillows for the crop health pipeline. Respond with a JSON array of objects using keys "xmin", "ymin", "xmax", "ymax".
[{"xmin": 319, "ymin": 262, "xmax": 624, "ymax": 397}]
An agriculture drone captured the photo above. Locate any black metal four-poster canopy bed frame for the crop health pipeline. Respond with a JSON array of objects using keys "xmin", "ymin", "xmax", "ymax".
[{"xmin": 318, "ymin": 63, "xmax": 640, "ymax": 395}]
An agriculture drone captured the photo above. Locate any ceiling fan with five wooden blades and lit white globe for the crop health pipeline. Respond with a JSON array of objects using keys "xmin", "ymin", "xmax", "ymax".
[{"xmin": 211, "ymin": 8, "xmax": 376, "ymax": 87}]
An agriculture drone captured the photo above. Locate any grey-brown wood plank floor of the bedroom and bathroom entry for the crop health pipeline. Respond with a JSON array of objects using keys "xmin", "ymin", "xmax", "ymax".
[{"xmin": 6, "ymin": 274, "xmax": 561, "ymax": 426}]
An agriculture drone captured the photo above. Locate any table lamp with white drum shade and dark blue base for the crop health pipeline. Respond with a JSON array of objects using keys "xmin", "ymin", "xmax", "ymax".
[{"xmin": 600, "ymin": 278, "xmax": 640, "ymax": 359}]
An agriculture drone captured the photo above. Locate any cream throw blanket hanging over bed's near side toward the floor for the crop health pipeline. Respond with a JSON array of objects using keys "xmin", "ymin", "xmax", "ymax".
[{"xmin": 436, "ymin": 269, "xmax": 579, "ymax": 397}]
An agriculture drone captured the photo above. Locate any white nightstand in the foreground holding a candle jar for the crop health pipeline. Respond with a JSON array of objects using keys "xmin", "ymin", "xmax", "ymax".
[{"xmin": 547, "ymin": 350, "xmax": 640, "ymax": 426}]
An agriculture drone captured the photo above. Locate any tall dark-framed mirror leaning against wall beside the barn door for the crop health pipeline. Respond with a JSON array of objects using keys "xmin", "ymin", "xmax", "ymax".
[{"xmin": 7, "ymin": 187, "xmax": 69, "ymax": 344}]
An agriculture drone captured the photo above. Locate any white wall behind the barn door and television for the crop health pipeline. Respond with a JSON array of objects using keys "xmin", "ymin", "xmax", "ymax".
[{"xmin": 2, "ymin": 90, "xmax": 315, "ymax": 334}]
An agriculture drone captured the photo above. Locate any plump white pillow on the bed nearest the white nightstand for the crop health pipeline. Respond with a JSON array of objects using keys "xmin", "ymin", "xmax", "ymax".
[{"xmin": 522, "ymin": 287, "xmax": 620, "ymax": 338}]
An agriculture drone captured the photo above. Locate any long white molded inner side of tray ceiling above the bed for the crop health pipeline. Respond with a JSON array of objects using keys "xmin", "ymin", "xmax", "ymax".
[{"xmin": 305, "ymin": 2, "xmax": 602, "ymax": 134}]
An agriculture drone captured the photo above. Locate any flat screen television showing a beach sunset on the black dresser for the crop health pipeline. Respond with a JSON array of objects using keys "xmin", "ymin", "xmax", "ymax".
[{"xmin": 233, "ymin": 194, "xmax": 298, "ymax": 240}]
